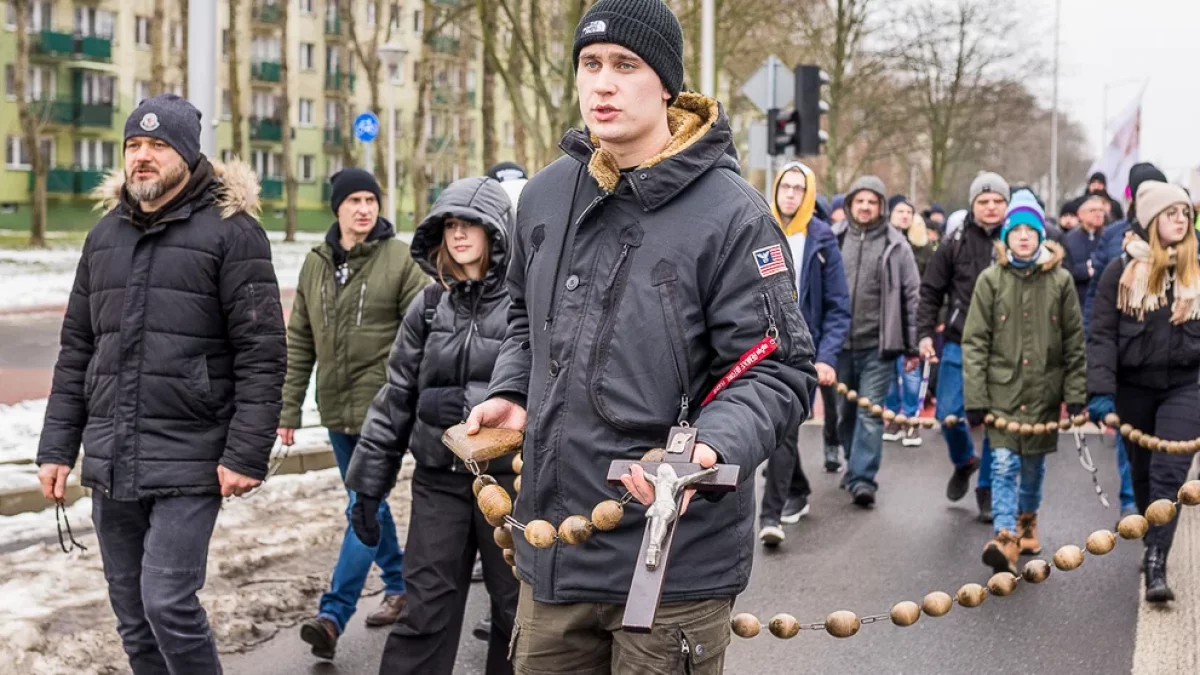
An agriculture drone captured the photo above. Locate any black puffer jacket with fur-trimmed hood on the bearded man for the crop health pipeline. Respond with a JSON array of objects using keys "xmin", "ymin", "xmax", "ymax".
[{"xmin": 37, "ymin": 159, "xmax": 287, "ymax": 500}]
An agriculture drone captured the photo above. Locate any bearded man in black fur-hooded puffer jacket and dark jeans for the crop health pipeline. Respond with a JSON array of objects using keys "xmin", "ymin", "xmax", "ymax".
[{"xmin": 37, "ymin": 94, "xmax": 287, "ymax": 675}]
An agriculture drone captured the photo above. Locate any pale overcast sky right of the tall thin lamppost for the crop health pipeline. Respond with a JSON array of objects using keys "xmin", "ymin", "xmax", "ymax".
[{"xmin": 1060, "ymin": 0, "xmax": 1200, "ymax": 180}]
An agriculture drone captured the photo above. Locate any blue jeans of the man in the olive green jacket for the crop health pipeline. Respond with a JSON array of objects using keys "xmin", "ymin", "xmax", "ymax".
[{"xmin": 319, "ymin": 431, "xmax": 404, "ymax": 633}]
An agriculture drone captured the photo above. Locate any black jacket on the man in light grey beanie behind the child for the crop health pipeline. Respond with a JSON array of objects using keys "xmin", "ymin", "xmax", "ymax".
[{"xmin": 917, "ymin": 215, "xmax": 1000, "ymax": 342}]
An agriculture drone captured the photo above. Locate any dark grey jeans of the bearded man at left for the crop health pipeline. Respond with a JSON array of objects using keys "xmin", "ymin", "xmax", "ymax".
[{"xmin": 91, "ymin": 492, "xmax": 222, "ymax": 675}]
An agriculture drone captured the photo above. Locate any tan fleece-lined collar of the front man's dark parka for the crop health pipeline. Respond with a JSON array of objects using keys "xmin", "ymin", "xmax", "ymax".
[{"xmin": 559, "ymin": 91, "xmax": 740, "ymax": 210}]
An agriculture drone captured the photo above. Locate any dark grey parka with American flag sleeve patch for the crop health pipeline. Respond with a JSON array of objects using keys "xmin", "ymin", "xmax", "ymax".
[{"xmin": 490, "ymin": 92, "xmax": 814, "ymax": 603}]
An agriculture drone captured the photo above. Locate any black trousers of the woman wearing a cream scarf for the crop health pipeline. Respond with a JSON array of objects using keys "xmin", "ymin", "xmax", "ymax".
[{"xmin": 1116, "ymin": 384, "xmax": 1200, "ymax": 550}]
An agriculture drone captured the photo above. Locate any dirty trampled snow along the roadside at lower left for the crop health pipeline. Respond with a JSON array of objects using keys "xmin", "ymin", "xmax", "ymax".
[{"xmin": 0, "ymin": 462, "xmax": 412, "ymax": 675}]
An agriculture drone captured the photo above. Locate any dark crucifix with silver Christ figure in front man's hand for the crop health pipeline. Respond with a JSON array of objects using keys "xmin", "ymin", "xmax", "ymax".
[{"xmin": 608, "ymin": 426, "xmax": 738, "ymax": 633}]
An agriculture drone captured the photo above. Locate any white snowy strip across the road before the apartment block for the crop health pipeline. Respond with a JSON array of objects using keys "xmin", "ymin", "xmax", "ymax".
[{"xmin": 0, "ymin": 227, "xmax": 413, "ymax": 311}]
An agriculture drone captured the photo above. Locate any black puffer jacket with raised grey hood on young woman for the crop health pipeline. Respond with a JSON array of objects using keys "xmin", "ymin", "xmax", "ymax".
[{"xmin": 346, "ymin": 178, "xmax": 512, "ymax": 497}]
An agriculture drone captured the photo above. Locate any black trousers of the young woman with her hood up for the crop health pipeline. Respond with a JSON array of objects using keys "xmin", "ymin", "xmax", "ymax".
[{"xmin": 379, "ymin": 466, "xmax": 521, "ymax": 675}]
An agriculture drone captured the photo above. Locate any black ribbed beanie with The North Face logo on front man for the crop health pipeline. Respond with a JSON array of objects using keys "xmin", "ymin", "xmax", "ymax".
[{"xmin": 571, "ymin": 0, "xmax": 683, "ymax": 102}]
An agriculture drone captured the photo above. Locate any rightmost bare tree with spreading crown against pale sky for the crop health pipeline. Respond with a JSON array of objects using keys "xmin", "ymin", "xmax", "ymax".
[{"xmin": 893, "ymin": 0, "xmax": 1038, "ymax": 201}]
